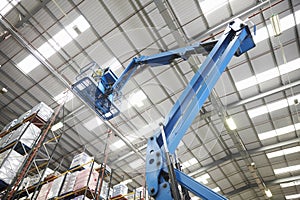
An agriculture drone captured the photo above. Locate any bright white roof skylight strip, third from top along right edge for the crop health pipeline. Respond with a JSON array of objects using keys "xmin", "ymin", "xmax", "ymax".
[{"xmin": 247, "ymin": 94, "xmax": 300, "ymax": 118}]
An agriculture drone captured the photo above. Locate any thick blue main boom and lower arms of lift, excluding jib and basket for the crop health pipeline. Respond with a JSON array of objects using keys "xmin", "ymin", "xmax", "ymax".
[{"xmin": 146, "ymin": 19, "xmax": 255, "ymax": 200}]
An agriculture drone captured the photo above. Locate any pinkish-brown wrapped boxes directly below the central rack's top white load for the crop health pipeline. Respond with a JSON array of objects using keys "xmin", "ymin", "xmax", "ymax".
[{"xmin": 74, "ymin": 169, "xmax": 99, "ymax": 191}]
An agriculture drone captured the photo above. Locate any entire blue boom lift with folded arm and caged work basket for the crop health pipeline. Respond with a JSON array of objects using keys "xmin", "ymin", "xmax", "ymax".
[{"xmin": 72, "ymin": 19, "xmax": 255, "ymax": 200}]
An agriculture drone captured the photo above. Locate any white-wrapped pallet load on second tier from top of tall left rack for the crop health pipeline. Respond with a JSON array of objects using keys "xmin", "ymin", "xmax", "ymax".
[{"xmin": 9, "ymin": 122, "xmax": 41, "ymax": 148}]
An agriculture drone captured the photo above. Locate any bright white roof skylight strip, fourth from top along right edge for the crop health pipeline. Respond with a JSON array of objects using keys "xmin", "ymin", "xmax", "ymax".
[{"xmin": 258, "ymin": 123, "xmax": 300, "ymax": 140}]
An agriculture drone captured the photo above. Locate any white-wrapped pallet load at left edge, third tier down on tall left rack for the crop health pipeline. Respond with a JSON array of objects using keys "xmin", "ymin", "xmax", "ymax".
[{"xmin": 0, "ymin": 149, "xmax": 25, "ymax": 184}]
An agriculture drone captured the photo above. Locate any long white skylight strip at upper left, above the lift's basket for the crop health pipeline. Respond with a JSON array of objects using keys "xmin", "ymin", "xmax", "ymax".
[{"xmin": 16, "ymin": 15, "xmax": 90, "ymax": 74}]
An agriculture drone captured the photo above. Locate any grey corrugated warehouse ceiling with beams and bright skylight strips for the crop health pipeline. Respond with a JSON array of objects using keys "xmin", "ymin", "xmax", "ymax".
[{"xmin": 0, "ymin": 0, "xmax": 300, "ymax": 200}]
